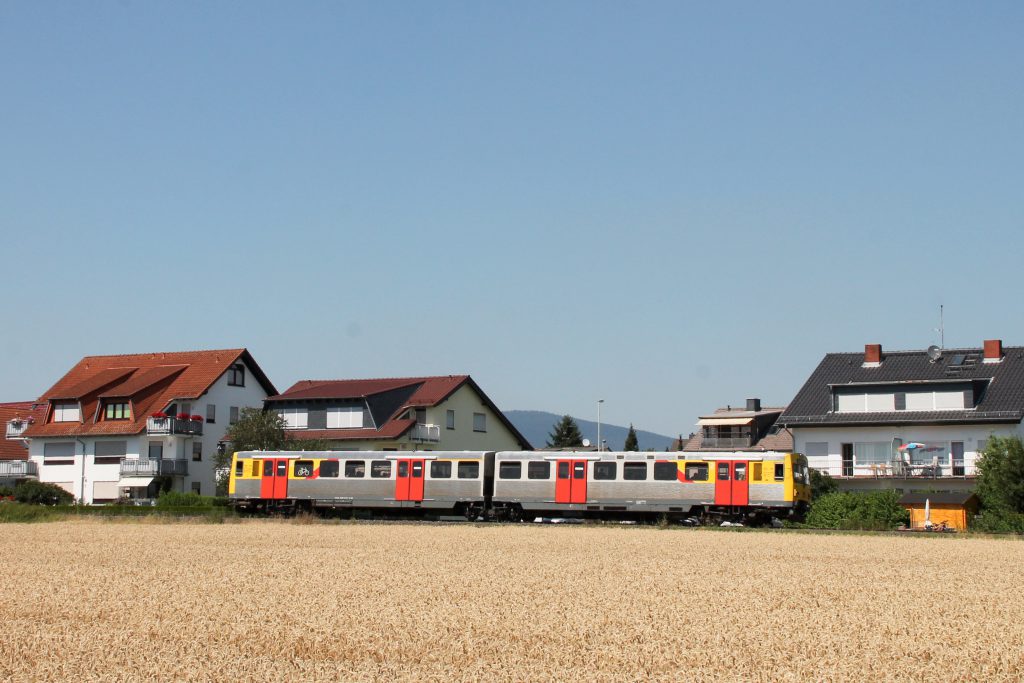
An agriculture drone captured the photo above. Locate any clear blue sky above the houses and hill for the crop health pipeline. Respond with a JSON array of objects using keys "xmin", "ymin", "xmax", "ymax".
[{"xmin": 0, "ymin": 0, "xmax": 1024, "ymax": 438}]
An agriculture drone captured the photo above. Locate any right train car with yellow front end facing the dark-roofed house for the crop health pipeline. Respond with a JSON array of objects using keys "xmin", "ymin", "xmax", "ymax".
[{"xmin": 492, "ymin": 452, "xmax": 811, "ymax": 521}]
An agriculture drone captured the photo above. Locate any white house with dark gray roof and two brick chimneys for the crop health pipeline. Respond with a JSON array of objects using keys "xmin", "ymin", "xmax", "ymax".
[{"xmin": 778, "ymin": 339, "xmax": 1024, "ymax": 492}]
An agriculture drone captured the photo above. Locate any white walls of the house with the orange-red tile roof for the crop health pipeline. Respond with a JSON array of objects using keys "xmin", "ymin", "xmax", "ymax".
[{"xmin": 29, "ymin": 358, "xmax": 266, "ymax": 505}]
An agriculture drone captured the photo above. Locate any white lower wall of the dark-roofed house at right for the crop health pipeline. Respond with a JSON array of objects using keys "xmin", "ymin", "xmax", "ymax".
[{"xmin": 791, "ymin": 424, "xmax": 1024, "ymax": 476}]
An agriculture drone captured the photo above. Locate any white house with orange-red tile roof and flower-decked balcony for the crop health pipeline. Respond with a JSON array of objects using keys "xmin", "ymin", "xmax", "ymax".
[{"xmin": 24, "ymin": 348, "xmax": 276, "ymax": 504}]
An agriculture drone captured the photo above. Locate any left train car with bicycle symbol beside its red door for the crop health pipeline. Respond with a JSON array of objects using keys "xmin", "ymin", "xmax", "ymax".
[{"xmin": 227, "ymin": 451, "xmax": 494, "ymax": 518}]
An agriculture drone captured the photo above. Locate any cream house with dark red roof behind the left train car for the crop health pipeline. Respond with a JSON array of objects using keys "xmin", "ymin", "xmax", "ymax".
[{"xmin": 265, "ymin": 375, "xmax": 530, "ymax": 451}]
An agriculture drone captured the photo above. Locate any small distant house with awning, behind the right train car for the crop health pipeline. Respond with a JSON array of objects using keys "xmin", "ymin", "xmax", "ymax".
[{"xmin": 681, "ymin": 398, "xmax": 793, "ymax": 452}]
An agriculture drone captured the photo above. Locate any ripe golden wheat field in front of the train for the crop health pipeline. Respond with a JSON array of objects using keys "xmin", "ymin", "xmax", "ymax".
[{"xmin": 0, "ymin": 520, "xmax": 1024, "ymax": 681}]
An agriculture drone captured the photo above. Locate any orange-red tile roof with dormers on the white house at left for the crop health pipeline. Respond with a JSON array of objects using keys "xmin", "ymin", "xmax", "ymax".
[{"xmin": 25, "ymin": 348, "xmax": 276, "ymax": 437}]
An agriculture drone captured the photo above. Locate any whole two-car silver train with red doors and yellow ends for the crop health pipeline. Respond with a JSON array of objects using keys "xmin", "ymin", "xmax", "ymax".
[{"xmin": 228, "ymin": 451, "xmax": 810, "ymax": 520}]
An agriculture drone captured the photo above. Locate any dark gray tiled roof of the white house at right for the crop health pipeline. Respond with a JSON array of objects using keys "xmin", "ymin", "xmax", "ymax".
[{"xmin": 777, "ymin": 346, "xmax": 1024, "ymax": 427}]
